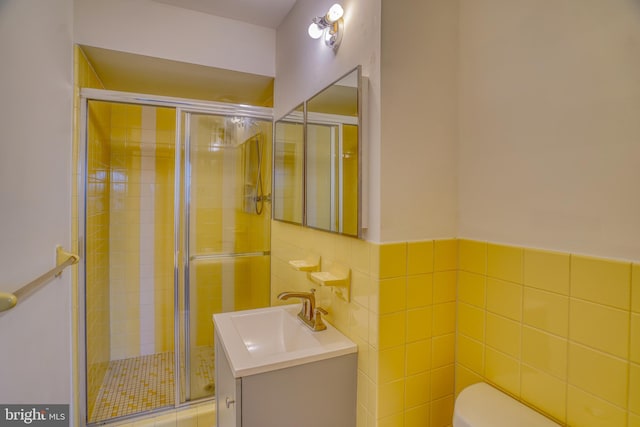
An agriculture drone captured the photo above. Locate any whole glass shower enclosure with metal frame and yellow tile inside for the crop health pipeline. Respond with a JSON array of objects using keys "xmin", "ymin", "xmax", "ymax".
[{"xmin": 79, "ymin": 90, "xmax": 272, "ymax": 424}]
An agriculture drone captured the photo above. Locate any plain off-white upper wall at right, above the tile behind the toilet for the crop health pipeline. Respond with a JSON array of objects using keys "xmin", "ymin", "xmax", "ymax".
[{"xmin": 459, "ymin": 0, "xmax": 640, "ymax": 260}]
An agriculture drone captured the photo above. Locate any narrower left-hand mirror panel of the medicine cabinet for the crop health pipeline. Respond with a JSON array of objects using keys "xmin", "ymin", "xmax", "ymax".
[{"xmin": 273, "ymin": 104, "xmax": 304, "ymax": 224}]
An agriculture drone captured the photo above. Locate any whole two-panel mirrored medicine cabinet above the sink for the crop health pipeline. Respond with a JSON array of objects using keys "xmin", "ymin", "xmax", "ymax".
[{"xmin": 273, "ymin": 67, "xmax": 362, "ymax": 237}]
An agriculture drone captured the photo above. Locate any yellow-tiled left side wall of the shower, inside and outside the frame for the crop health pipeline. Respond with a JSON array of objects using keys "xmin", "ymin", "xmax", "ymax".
[{"xmin": 71, "ymin": 46, "xmax": 111, "ymax": 422}]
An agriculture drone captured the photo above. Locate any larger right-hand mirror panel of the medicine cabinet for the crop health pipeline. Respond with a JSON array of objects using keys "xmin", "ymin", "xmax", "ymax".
[{"xmin": 305, "ymin": 68, "xmax": 360, "ymax": 236}]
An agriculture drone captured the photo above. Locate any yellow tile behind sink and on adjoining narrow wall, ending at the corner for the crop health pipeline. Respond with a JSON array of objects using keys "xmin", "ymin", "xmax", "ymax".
[{"xmin": 271, "ymin": 221, "xmax": 458, "ymax": 426}]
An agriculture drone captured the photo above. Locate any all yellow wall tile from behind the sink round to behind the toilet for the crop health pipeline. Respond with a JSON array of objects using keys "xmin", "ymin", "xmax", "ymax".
[{"xmin": 271, "ymin": 231, "xmax": 640, "ymax": 427}]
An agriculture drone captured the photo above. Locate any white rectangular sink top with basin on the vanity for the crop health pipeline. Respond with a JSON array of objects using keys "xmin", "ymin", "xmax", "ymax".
[{"xmin": 213, "ymin": 304, "xmax": 357, "ymax": 378}]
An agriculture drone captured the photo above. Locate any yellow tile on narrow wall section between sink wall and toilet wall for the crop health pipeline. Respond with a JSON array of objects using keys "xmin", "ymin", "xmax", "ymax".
[{"xmin": 371, "ymin": 239, "xmax": 458, "ymax": 426}]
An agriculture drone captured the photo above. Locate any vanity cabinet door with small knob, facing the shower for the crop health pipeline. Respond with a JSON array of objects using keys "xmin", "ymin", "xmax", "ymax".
[{"xmin": 215, "ymin": 334, "xmax": 242, "ymax": 427}]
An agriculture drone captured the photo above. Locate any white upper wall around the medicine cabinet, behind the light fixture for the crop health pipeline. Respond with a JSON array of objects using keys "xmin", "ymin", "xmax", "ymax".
[{"xmin": 274, "ymin": 0, "xmax": 381, "ymax": 241}]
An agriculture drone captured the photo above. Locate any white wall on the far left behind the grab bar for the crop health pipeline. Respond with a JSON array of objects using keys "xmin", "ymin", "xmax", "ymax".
[{"xmin": 0, "ymin": 0, "xmax": 73, "ymax": 404}]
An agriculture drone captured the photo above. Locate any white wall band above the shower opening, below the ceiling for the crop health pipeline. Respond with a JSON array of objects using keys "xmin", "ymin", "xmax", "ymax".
[{"xmin": 74, "ymin": 0, "xmax": 275, "ymax": 76}]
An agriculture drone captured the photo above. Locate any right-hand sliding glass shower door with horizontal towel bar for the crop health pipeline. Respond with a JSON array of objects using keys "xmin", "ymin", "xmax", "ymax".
[{"xmin": 181, "ymin": 113, "xmax": 272, "ymax": 401}]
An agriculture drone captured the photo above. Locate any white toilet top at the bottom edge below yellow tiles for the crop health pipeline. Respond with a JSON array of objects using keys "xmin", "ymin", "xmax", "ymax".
[{"xmin": 453, "ymin": 383, "xmax": 560, "ymax": 427}]
